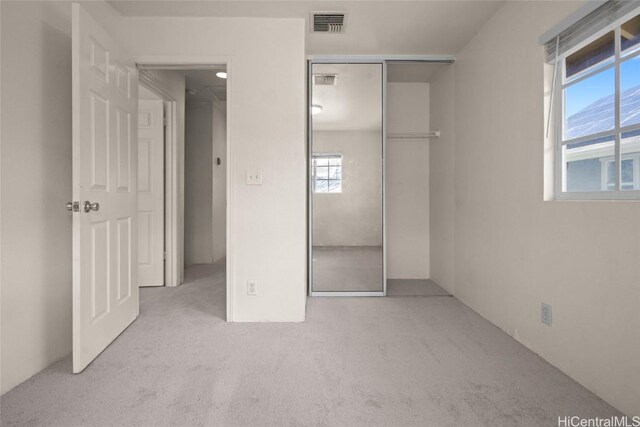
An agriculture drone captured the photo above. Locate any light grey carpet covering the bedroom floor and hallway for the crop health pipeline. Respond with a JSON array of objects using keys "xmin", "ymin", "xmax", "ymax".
[{"xmin": 1, "ymin": 261, "xmax": 619, "ymax": 426}]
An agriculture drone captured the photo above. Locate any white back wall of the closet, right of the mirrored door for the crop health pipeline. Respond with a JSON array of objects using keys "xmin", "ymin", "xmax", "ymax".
[{"xmin": 386, "ymin": 83, "xmax": 430, "ymax": 279}]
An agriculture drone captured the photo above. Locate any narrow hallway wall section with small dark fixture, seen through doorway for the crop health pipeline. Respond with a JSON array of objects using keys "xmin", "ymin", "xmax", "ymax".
[{"xmin": 211, "ymin": 102, "xmax": 227, "ymax": 262}]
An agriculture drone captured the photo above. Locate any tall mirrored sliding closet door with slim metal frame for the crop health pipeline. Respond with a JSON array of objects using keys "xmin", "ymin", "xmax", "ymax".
[{"xmin": 309, "ymin": 62, "xmax": 385, "ymax": 296}]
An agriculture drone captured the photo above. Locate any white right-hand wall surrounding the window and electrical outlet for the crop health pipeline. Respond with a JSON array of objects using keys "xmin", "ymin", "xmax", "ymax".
[{"xmin": 431, "ymin": 2, "xmax": 640, "ymax": 415}]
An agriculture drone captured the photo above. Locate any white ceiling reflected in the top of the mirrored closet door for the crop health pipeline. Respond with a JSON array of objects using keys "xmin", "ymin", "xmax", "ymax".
[{"xmin": 312, "ymin": 64, "xmax": 382, "ymax": 131}]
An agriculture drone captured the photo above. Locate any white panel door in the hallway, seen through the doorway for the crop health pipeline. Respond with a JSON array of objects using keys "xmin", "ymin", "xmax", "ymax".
[{"xmin": 138, "ymin": 99, "xmax": 164, "ymax": 286}]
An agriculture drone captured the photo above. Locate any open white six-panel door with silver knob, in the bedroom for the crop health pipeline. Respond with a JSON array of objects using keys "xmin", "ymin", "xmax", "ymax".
[{"xmin": 72, "ymin": 4, "xmax": 139, "ymax": 372}]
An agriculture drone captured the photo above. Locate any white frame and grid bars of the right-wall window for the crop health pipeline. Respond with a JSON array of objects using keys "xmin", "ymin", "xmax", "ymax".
[{"xmin": 553, "ymin": 9, "xmax": 640, "ymax": 201}]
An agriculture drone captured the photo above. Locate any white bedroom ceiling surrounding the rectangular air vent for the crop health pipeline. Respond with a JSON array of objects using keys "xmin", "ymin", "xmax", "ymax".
[{"xmin": 110, "ymin": 0, "xmax": 503, "ymax": 55}]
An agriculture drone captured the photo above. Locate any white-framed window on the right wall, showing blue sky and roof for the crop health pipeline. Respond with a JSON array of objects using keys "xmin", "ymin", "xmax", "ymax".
[{"xmin": 555, "ymin": 10, "xmax": 640, "ymax": 199}]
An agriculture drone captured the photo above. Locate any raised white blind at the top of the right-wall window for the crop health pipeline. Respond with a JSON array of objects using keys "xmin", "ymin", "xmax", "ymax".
[{"xmin": 540, "ymin": 0, "xmax": 640, "ymax": 62}]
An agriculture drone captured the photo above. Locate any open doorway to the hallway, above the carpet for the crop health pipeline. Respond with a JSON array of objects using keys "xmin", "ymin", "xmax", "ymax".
[{"xmin": 138, "ymin": 65, "xmax": 227, "ymax": 312}]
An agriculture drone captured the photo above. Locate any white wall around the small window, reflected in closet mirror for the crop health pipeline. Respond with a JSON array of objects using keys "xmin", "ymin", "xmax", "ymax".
[{"xmin": 313, "ymin": 130, "xmax": 382, "ymax": 246}]
